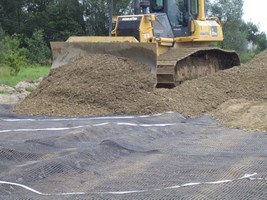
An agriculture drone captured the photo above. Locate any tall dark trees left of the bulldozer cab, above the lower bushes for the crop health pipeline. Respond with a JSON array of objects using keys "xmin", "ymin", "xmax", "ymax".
[{"xmin": 0, "ymin": 0, "xmax": 133, "ymax": 40}]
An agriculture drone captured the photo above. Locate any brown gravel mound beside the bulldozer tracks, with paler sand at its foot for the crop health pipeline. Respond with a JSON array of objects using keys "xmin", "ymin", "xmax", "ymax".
[{"xmin": 157, "ymin": 52, "xmax": 267, "ymax": 131}]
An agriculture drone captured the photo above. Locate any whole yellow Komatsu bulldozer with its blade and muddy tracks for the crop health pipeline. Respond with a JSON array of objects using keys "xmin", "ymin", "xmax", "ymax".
[{"xmin": 51, "ymin": 0, "xmax": 240, "ymax": 87}]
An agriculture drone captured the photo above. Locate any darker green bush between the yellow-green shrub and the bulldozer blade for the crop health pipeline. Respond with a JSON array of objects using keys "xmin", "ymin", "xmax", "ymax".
[{"xmin": 25, "ymin": 30, "xmax": 51, "ymax": 64}]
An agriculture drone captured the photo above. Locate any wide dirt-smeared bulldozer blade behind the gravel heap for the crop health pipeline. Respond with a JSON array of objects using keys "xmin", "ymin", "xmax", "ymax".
[{"xmin": 50, "ymin": 42, "xmax": 157, "ymax": 74}]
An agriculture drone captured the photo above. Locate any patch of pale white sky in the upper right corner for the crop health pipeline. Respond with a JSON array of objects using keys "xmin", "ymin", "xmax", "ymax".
[{"xmin": 243, "ymin": 0, "xmax": 267, "ymax": 33}]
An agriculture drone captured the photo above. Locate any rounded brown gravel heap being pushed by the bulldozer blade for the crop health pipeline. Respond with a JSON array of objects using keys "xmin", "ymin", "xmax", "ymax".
[{"xmin": 15, "ymin": 54, "xmax": 169, "ymax": 116}]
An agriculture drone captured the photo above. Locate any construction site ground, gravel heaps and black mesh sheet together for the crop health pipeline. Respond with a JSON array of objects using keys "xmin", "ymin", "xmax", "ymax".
[{"xmin": 0, "ymin": 52, "xmax": 267, "ymax": 200}]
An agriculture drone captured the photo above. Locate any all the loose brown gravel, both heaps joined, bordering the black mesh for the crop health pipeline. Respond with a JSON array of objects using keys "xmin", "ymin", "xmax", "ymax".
[{"xmin": 14, "ymin": 52, "xmax": 267, "ymax": 130}]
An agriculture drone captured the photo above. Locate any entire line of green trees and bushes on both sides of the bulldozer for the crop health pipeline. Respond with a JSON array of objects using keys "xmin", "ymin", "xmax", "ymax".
[{"xmin": 0, "ymin": 0, "xmax": 267, "ymax": 73}]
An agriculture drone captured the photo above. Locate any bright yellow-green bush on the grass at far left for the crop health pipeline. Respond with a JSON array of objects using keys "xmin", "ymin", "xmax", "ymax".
[{"xmin": 3, "ymin": 36, "xmax": 27, "ymax": 76}]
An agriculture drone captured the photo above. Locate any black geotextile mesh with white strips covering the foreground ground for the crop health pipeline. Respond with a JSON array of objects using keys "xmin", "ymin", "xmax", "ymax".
[{"xmin": 0, "ymin": 106, "xmax": 267, "ymax": 200}]
